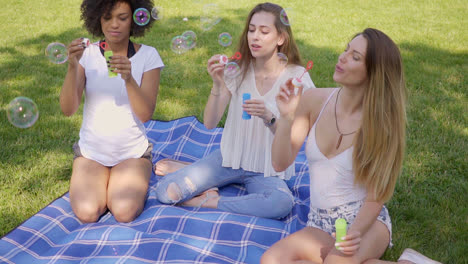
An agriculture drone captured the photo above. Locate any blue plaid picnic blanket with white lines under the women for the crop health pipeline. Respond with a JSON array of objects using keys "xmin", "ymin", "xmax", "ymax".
[{"xmin": 0, "ymin": 117, "xmax": 309, "ymax": 264}]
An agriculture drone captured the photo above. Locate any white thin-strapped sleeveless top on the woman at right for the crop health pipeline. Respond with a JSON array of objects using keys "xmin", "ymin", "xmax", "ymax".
[{"xmin": 305, "ymin": 90, "xmax": 367, "ymax": 209}]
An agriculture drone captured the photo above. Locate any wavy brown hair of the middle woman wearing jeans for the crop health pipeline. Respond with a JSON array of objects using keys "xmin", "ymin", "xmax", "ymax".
[{"xmin": 237, "ymin": 2, "xmax": 302, "ymax": 80}]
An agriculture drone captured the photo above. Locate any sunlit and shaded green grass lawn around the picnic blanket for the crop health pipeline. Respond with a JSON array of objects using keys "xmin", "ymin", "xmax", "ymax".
[{"xmin": 0, "ymin": 0, "xmax": 468, "ymax": 263}]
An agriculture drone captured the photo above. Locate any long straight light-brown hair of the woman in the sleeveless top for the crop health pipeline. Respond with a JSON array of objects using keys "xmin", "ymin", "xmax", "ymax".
[{"xmin": 353, "ymin": 28, "xmax": 406, "ymax": 202}]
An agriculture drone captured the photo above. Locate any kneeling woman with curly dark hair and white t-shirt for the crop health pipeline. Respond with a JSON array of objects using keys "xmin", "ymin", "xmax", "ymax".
[{"xmin": 60, "ymin": 0, "xmax": 164, "ymax": 223}]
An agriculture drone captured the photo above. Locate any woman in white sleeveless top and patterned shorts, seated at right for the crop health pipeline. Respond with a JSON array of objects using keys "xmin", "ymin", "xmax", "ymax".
[{"xmin": 261, "ymin": 28, "xmax": 436, "ymax": 264}]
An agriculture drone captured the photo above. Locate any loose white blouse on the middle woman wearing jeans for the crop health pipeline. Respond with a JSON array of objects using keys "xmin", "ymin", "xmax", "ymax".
[{"xmin": 221, "ymin": 64, "xmax": 315, "ymax": 179}]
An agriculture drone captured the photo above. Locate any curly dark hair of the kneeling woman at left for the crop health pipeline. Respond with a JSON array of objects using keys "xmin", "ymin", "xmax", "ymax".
[{"xmin": 81, "ymin": 0, "xmax": 154, "ymax": 37}]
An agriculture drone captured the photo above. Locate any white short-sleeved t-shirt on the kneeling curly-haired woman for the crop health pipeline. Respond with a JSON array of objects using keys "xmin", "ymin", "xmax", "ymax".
[{"xmin": 78, "ymin": 45, "xmax": 164, "ymax": 166}]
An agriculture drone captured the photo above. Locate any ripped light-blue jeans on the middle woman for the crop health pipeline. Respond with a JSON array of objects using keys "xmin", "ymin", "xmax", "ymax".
[{"xmin": 156, "ymin": 150, "xmax": 294, "ymax": 218}]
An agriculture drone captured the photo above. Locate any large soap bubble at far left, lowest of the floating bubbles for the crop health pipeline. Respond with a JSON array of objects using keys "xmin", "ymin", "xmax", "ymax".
[{"xmin": 7, "ymin": 96, "xmax": 39, "ymax": 128}]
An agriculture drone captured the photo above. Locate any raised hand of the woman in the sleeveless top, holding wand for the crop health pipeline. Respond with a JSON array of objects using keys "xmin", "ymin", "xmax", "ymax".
[{"xmin": 276, "ymin": 79, "xmax": 304, "ymax": 120}]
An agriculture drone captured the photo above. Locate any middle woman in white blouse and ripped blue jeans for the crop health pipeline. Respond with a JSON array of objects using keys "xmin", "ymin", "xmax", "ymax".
[{"xmin": 156, "ymin": 3, "xmax": 314, "ymax": 218}]
